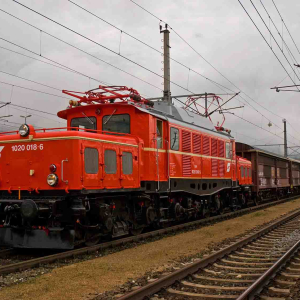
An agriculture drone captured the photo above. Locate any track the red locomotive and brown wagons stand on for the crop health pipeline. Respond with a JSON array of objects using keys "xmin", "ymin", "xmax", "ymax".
[{"xmin": 0, "ymin": 196, "xmax": 299, "ymax": 275}]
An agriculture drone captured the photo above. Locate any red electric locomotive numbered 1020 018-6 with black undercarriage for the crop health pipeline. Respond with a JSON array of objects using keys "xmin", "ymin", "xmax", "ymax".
[{"xmin": 0, "ymin": 86, "xmax": 252, "ymax": 249}]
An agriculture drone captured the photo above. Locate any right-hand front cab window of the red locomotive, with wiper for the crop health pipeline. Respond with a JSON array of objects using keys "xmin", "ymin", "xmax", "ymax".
[{"xmin": 102, "ymin": 113, "xmax": 130, "ymax": 133}]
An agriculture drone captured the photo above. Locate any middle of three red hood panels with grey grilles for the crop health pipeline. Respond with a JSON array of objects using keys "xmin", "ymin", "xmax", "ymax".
[{"xmin": 102, "ymin": 143, "xmax": 121, "ymax": 189}]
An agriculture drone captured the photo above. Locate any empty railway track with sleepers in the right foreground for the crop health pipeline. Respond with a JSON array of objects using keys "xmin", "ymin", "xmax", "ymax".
[{"xmin": 118, "ymin": 203, "xmax": 300, "ymax": 300}]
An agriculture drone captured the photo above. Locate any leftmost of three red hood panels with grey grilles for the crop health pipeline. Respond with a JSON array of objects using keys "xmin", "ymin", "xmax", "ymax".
[{"xmin": 81, "ymin": 141, "xmax": 102, "ymax": 189}]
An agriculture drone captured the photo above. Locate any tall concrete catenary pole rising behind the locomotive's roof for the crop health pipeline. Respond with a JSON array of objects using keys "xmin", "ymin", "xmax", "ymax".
[{"xmin": 159, "ymin": 24, "xmax": 172, "ymax": 106}]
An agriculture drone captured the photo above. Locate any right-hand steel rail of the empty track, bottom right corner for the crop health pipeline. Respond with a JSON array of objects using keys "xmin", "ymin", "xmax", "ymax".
[{"xmin": 237, "ymin": 241, "xmax": 300, "ymax": 300}]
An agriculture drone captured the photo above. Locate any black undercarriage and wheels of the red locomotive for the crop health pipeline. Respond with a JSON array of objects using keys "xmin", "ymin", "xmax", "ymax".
[{"xmin": 0, "ymin": 189, "xmax": 251, "ymax": 249}]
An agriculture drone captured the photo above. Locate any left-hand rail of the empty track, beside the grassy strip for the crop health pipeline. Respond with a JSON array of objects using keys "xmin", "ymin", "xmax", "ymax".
[{"xmin": 118, "ymin": 209, "xmax": 300, "ymax": 300}]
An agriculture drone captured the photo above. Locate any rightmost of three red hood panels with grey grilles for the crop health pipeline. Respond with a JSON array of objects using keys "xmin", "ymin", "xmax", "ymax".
[{"xmin": 119, "ymin": 146, "xmax": 139, "ymax": 188}]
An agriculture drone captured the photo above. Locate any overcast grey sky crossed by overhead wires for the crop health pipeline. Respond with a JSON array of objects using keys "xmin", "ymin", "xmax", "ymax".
[{"xmin": 0, "ymin": 0, "xmax": 300, "ymax": 155}]
